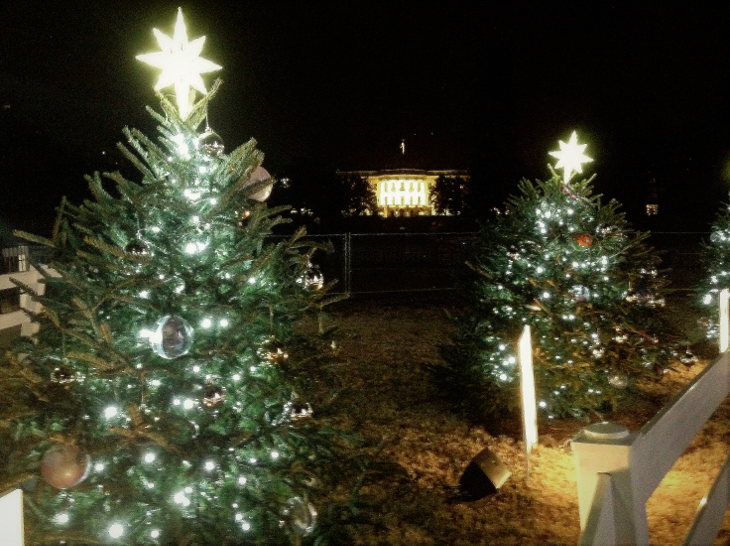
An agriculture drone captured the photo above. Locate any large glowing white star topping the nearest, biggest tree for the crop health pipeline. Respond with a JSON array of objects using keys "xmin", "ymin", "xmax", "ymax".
[{"xmin": 137, "ymin": 8, "xmax": 221, "ymax": 119}]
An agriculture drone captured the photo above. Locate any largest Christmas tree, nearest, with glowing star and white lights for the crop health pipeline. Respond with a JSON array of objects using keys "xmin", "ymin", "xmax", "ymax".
[{"xmin": 0, "ymin": 12, "xmax": 347, "ymax": 546}]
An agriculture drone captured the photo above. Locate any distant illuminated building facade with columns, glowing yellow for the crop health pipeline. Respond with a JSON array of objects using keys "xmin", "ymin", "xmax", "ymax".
[{"xmin": 339, "ymin": 169, "xmax": 469, "ymax": 217}]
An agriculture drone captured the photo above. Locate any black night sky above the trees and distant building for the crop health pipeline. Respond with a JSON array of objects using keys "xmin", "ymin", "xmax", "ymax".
[{"xmin": 0, "ymin": 0, "xmax": 730, "ymax": 232}]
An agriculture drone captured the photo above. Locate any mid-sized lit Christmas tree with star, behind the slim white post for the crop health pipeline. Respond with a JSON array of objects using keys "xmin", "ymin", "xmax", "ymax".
[{"xmin": 432, "ymin": 133, "xmax": 673, "ymax": 420}]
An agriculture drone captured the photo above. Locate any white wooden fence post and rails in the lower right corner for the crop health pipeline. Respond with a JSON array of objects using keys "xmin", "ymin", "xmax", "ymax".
[{"xmin": 572, "ymin": 346, "xmax": 730, "ymax": 546}]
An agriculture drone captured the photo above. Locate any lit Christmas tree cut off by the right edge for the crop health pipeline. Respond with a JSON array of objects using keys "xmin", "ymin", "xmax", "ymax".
[{"xmin": 696, "ymin": 198, "xmax": 730, "ymax": 339}]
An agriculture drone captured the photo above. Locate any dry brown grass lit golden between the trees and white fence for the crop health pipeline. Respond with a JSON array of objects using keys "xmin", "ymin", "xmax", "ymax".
[{"xmin": 333, "ymin": 296, "xmax": 730, "ymax": 546}]
